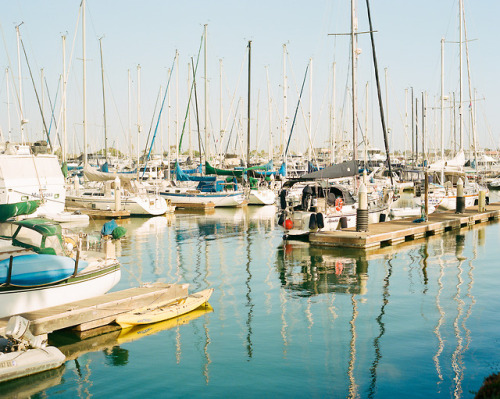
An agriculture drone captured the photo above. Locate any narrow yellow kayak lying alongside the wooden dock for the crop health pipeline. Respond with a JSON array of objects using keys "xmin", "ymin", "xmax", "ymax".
[{"xmin": 116, "ymin": 288, "xmax": 214, "ymax": 328}]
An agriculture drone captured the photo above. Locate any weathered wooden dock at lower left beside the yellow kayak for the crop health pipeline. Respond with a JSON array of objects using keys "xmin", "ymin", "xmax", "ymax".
[{"xmin": 0, "ymin": 283, "xmax": 188, "ymax": 336}]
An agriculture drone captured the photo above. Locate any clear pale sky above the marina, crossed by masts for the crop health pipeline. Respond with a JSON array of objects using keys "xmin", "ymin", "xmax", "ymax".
[{"xmin": 0, "ymin": 0, "xmax": 500, "ymax": 159}]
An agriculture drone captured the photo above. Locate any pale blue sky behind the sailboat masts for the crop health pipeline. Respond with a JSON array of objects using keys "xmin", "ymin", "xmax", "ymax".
[{"xmin": 0, "ymin": 0, "xmax": 500, "ymax": 158}]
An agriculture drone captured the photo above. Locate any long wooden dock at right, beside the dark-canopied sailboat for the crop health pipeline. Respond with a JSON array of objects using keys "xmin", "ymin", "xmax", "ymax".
[{"xmin": 309, "ymin": 203, "xmax": 500, "ymax": 250}]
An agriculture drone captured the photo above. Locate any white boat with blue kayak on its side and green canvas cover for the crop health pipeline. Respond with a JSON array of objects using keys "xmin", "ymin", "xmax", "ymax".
[{"xmin": 0, "ymin": 218, "xmax": 121, "ymax": 318}]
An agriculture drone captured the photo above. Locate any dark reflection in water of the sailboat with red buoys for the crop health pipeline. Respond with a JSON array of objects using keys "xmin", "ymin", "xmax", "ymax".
[{"xmin": 277, "ymin": 241, "xmax": 368, "ymax": 296}]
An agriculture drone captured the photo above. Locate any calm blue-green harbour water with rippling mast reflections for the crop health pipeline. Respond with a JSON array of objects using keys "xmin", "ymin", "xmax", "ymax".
[{"xmin": 0, "ymin": 207, "xmax": 500, "ymax": 398}]
